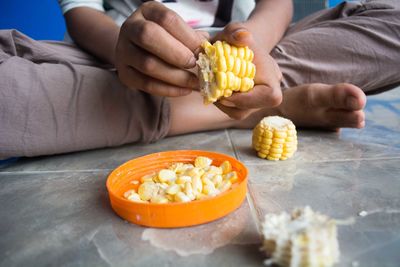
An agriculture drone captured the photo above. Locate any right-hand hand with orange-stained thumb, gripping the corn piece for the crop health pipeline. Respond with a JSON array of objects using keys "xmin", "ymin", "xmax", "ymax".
[{"xmin": 213, "ymin": 23, "xmax": 282, "ymax": 120}]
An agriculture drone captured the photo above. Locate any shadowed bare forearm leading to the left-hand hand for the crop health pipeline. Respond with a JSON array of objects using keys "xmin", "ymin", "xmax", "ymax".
[{"xmin": 65, "ymin": 7, "xmax": 119, "ymax": 65}]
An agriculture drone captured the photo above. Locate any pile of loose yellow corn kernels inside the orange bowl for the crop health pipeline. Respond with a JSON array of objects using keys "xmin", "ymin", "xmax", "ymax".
[{"xmin": 124, "ymin": 157, "xmax": 238, "ymax": 203}]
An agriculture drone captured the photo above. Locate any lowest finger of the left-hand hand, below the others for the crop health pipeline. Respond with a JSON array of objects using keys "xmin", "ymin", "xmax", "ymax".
[{"xmin": 118, "ymin": 66, "xmax": 192, "ymax": 97}]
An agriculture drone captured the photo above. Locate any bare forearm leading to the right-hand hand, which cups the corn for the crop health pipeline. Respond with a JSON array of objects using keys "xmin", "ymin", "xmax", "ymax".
[{"xmin": 245, "ymin": 0, "xmax": 293, "ymax": 53}]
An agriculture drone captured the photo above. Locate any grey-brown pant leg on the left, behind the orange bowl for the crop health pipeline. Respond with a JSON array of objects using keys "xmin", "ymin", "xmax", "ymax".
[{"xmin": 0, "ymin": 31, "xmax": 169, "ymax": 158}]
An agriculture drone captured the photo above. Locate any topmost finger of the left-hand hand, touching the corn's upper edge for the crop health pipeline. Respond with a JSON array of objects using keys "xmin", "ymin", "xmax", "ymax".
[{"xmin": 142, "ymin": 1, "xmax": 205, "ymax": 52}]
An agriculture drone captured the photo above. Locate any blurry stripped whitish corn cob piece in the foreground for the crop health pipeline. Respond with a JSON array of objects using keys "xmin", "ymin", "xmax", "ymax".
[{"xmin": 262, "ymin": 206, "xmax": 339, "ymax": 267}]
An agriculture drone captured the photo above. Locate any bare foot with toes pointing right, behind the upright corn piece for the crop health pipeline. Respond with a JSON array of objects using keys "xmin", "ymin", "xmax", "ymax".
[{"xmin": 239, "ymin": 83, "xmax": 366, "ymax": 129}]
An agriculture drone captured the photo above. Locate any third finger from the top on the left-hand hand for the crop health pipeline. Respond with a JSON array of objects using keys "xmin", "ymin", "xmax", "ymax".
[{"xmin": 124, "ymin": 43, "xmax": 199, "ymax": 89}]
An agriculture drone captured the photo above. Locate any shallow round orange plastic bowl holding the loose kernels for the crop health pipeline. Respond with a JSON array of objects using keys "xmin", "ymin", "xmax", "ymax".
[{"xmin": 107, "ymin": 150, "xmax": 247, "ymax": 228}]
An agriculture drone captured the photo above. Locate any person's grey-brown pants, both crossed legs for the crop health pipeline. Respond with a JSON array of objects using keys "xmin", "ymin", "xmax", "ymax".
[{"xmin": 0, "ymin": 0, "xmax": 400, "ymax": 158}]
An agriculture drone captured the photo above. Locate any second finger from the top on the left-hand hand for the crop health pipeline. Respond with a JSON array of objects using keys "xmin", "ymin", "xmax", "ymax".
[{"xmin": 121, "ymin": 19, "xmax": 196, "ymax": 68}]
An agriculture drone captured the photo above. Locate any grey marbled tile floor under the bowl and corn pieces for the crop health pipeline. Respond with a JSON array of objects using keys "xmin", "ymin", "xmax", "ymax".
[{"xmin": 0, "ymin": 89, "xmax": 400, "ymax": 267}]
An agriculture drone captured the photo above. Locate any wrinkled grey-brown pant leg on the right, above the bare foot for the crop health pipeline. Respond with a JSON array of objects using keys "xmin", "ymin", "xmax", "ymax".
[{"xmin": 271, "ymin": 0, "xmax": 400, "ymax": 94}]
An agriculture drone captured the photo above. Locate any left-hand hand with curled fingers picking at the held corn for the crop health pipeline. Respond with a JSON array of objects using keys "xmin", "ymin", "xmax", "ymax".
[{"xmin": 115, "ymin": 1, "xmax": 206, "ymax": 96}]
